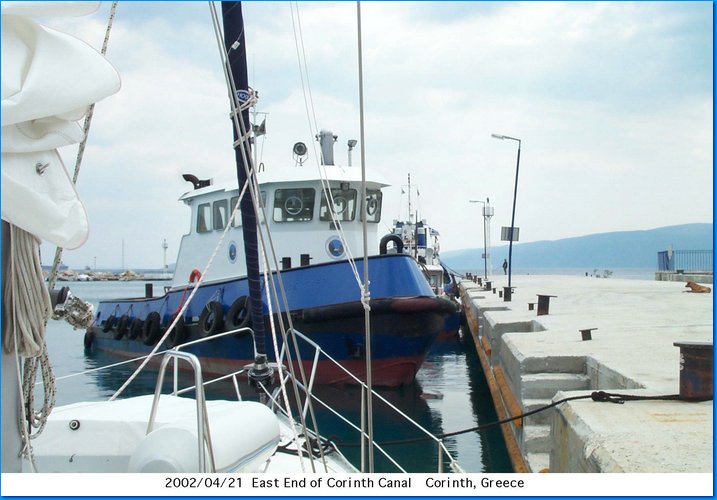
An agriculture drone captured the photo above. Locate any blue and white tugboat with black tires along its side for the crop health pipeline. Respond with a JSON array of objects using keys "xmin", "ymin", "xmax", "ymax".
[{"xmin": 85, "ymin": 130, "xmax": 457, "ymax": 386}]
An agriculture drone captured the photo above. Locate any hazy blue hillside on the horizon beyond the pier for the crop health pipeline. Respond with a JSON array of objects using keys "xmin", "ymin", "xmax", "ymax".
[{"xmin": 441, "ymin": 224, "xmax": 713, "ymax": 269}]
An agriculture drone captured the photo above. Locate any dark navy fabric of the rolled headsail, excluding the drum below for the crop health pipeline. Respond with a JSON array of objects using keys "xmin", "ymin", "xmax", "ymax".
[{"xmin": 222, "ymin": 2, "xmax": 266, "ymax": 356}]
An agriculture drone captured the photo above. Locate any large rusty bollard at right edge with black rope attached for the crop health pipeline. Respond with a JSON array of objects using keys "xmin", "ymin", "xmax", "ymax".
[{"xmin": 673, "ymin": 342, "xmax": 714, "ymax": 401}]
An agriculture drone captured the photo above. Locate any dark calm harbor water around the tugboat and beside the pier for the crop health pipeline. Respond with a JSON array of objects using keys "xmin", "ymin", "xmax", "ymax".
[{"xmin": 47, "ymin": 281, "xmax": 512, "ymax": 473}]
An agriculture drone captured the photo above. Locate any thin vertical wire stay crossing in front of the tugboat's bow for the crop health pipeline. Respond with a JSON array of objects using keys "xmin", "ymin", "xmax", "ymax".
[{"xmin": 356, "ymin": 2, "xmax": 374, "ymax": 472}]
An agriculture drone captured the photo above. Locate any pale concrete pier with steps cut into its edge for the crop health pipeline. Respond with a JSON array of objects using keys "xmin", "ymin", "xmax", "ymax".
[{"xmin": 460, "ymin": 275, "xmax": 713, "ymax": 472}]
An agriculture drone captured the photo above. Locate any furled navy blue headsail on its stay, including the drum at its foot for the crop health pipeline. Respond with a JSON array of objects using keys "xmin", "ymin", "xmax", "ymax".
[{"xmin": 222, "ymin": 2, "xmax": 273, "ymax": 384}]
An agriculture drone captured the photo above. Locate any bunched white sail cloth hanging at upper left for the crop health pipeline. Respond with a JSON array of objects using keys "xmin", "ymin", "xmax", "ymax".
[{"xmin": 0, "ymin": 2, "xmax": 120, "ymax": 248}]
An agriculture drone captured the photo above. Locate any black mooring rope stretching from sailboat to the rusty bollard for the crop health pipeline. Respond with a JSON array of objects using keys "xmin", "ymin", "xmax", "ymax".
[{"xmin": 334, "ymin": 391, "xmax": 680, "ymax": 448}]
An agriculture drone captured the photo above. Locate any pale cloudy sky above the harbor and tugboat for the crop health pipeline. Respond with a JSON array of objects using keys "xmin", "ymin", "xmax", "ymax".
[{"xmin": 32, "ymin": 1, "xmax": 713, "ymax": 268}]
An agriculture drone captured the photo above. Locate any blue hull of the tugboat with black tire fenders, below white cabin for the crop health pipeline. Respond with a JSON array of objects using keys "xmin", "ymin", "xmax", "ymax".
[{"xmin": 88, "ymin": 255, "xmax": 455, "ymax": 386}]
